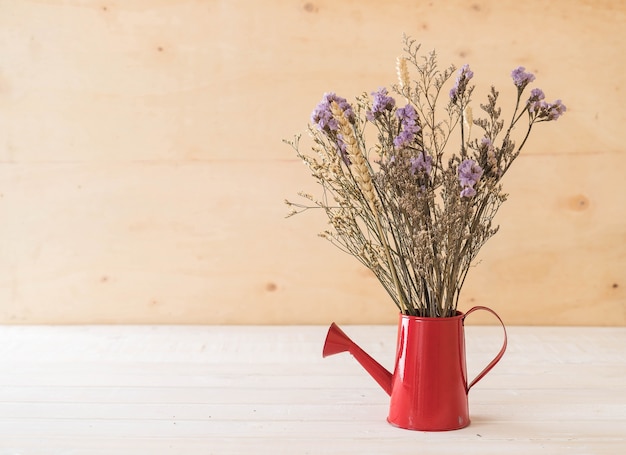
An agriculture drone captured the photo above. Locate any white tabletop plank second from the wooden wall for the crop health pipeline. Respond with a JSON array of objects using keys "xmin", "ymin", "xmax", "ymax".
[{"xmin": 2, "ymin": 357, "xmax": 624, "ymax": 395}]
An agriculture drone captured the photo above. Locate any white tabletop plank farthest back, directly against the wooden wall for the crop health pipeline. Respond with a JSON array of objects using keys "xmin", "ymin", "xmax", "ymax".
[{"xmin": 0, "ymin": 325, "xmax": 626, "ymax": 362}]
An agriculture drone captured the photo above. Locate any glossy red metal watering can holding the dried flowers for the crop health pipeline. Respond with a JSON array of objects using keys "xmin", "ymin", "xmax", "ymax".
[{"xmin": 322, "ymin": 306, "xmax": 507, "ymax": 431}]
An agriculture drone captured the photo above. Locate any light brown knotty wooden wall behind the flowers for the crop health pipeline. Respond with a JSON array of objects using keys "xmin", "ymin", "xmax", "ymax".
[{"xmin": 0, "ymin": 0, "xmax": 626, "ymax": 325}]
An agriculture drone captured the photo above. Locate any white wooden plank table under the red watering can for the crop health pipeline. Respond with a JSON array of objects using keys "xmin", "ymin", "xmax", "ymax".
[{"xmin": 0, "ymin": 326, "xmax": 626, "ymax": 455}]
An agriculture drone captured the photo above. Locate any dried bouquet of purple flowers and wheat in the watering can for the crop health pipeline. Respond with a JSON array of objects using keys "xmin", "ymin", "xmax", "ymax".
[{"xmin": 286, "ymin": 38, "xmax": 565, "ymax": 317}]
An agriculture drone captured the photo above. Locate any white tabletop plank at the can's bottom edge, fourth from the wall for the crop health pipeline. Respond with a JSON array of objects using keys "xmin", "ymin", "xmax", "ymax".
[{"xmin": 2, "ymin": 415, "xmax": 624, "ymax": 444}]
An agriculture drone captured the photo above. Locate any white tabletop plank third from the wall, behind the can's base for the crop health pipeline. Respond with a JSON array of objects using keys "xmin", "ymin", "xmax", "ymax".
[{"xmin": 0, "ymin": 390, "xmax": 626, "ymax": 424}]
